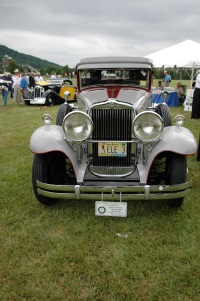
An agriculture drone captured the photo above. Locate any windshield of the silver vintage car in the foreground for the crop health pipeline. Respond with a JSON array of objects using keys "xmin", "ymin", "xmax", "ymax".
[{"xmin": 79, "ymin": 68, "xmax": 149, "ymax": 89}]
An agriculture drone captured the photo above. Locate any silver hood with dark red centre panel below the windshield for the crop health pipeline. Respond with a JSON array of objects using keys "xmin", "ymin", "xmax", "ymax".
[{"xmin": 77, "ymin": 87, "xmax": 151, "ymax": 109}]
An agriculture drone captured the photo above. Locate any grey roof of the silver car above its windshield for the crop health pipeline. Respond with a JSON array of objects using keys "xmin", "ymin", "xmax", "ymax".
[{"xmin": 76, "ymin": 56, "xmax": 153, "ymax": 69}]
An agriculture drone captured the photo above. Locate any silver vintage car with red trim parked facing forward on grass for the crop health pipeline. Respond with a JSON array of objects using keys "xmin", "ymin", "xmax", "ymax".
[{"xmin": 30, "ymin": 57, "xmax": 197, "ymax": 211}]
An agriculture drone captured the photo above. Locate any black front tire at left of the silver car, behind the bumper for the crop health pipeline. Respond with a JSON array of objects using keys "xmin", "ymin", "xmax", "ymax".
[{"xmin": 32, "ymin": 152, "xmax": 67, "ymax": 205}]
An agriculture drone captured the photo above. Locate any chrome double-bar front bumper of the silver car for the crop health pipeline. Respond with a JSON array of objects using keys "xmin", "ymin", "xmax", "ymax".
[{"xmin": 37, "ymin": 181, "xmax": 192, "ymax": 201}]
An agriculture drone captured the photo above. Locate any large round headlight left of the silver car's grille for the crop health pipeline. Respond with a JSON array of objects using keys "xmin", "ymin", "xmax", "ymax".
[{"xmin": 62, "ymin": 111, "xmax": 93, "ymax": 141}]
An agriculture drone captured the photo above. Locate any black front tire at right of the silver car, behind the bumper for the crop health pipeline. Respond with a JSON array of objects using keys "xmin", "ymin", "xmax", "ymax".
[{"xmin": 166, "ymin": 153, "xmax": 187, "ymax": 207}]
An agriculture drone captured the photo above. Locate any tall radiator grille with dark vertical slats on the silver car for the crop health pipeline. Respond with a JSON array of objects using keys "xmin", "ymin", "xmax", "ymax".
[{"xmin": 90, "ymin": 108, "xmax": 133, "ymax": 169}]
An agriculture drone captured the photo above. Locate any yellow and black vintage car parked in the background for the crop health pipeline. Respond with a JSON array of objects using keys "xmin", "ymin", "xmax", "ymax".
[{"xmin": 23, "ymin": 78, "xmax": 76, "ymax": 106}]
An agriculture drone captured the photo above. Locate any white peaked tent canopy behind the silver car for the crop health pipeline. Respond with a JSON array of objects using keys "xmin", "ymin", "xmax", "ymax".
[{"xmin": 145, "ymin": 40, "xmax": 200, "ymax": 83}]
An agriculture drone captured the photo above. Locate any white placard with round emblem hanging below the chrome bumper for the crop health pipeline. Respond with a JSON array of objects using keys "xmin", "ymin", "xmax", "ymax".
[{"xmin": 95, "ymin": 201, "xmax": 127, "ymax": 217}]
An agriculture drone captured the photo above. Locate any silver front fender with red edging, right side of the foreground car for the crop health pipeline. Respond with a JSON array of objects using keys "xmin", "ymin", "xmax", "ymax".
[{"xmin": 137, "ymin": 126, "xmax": 197, "ymax": 183}]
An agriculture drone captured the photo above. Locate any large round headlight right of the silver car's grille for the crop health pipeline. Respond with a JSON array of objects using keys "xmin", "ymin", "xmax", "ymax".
[{"xmin": 132, "ymin": 111, "xmax": 164, "ymax": 142}]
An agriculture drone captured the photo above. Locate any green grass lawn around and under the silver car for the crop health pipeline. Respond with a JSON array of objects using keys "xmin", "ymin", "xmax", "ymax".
[{"xmin": 0, "ymin": 99, "xmax": 200, "ymax": 301}]
